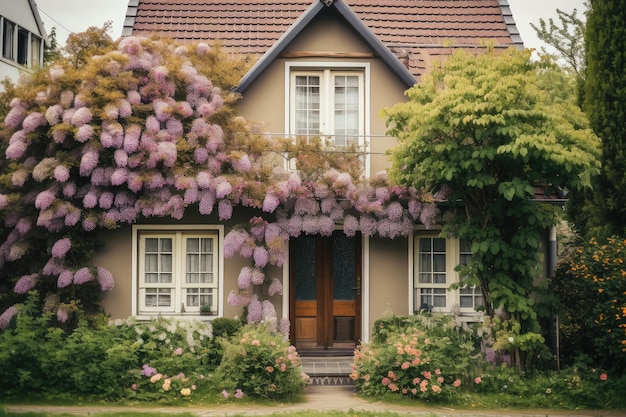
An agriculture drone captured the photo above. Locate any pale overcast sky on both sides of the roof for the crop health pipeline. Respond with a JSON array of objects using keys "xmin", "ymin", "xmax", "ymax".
[{"xmin": 35, "ymin": 0, "xmax": 585, "ymax": 50}]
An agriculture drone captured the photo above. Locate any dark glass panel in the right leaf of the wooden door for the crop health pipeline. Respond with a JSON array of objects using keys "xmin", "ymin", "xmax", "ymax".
[{"xmin": 333, "ymin": 233, "xmax": 355, "ymax": 300}]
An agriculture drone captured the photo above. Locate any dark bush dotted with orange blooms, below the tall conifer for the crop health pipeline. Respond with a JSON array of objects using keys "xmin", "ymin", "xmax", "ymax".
[{"xmin": 549, "ymin": 238, "xmax": 626, "ymax": 373}]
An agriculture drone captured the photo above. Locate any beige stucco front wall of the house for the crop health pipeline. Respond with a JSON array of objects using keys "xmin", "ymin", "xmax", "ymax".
[{"xmin": 100, "ymin": 9, "xmax": 408, "ymax": 334}]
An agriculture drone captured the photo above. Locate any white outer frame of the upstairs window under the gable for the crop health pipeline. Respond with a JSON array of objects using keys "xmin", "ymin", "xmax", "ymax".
[{"xmin": 285, "ymin": 61, "xmax": 371, "ymax": 176}]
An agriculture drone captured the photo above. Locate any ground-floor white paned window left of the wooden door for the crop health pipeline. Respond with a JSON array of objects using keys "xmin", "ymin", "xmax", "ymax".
[{"xmin": 136, "ymin": 228, "xmax": 220, "ymax": 315}]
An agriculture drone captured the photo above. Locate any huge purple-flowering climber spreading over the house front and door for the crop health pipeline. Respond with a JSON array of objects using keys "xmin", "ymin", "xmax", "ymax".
[{"xmin": 0, "ymin": 37, "xmax": 437, "ymax": 328}]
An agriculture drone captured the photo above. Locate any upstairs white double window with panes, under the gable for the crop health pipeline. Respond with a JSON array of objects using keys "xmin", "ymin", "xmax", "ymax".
[{"xmin": 289, "ymin": 68, "xmax": 365, "ymax": 146}]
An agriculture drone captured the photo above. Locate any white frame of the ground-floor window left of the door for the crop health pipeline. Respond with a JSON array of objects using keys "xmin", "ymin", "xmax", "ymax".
[{"xmin": 131, "ymin": 225, "xmax": 224, "ymax": 319}]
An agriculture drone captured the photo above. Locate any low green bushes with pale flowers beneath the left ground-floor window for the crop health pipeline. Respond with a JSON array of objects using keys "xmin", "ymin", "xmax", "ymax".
[{"xmin": 0, "ymin": 306, "xmax": 221, "ymax": 401}]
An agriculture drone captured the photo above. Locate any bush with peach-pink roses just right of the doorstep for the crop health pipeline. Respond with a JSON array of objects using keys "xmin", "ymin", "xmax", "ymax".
[{"xmin": 351, "ymin": 314, "xmax": 474, "ymax": 400}]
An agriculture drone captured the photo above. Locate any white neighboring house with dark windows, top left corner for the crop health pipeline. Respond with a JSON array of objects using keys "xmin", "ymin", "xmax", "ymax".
[{"xmin": 0, "ymin": 0, "xmax": 48, "ymax": 88}]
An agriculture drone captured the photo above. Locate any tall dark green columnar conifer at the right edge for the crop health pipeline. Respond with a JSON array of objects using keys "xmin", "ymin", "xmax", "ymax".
[{"xmin": 581, "ymin": 0, "xmax": 626, "ymax": 236}]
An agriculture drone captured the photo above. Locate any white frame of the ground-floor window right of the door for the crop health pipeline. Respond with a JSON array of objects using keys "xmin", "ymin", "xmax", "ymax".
[{"xmin": 409, "ymin": 233, "xmax": 481, "ymax": 321}]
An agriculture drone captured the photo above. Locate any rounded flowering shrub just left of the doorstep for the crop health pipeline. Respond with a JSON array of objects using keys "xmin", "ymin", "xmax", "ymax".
[{"xmin": 215, "ymin": 324, "xmax": 307, "ymax": 399}]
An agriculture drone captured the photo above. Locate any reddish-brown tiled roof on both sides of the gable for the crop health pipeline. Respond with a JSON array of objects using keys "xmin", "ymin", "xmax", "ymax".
[{"xmin": 123, "ymin": 0, "xmax": 522, "ymax": 78}]
